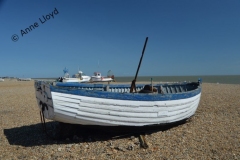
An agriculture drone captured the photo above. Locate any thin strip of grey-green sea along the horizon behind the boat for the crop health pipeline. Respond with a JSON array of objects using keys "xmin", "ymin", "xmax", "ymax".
[{"xmin": 32, "ymin": 75, "xmax": 240, "ymax": 84}]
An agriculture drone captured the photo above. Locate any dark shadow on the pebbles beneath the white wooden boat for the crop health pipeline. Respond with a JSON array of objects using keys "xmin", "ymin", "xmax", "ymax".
[{"xmin": 4, "ymin": 120, "xmax": 186, "ymax": 147}]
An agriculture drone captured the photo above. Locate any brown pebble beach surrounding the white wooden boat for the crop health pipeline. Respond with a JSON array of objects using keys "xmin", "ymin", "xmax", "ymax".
[{"xmin": 0, "ymin": 80, "xmax": 240, "ymax": 160}]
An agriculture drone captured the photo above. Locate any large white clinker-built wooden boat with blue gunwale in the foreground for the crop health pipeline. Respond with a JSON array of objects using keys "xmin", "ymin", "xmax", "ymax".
[{"xmin": 35, "ymin": 81, "xmax": 201, "ymax": 126}]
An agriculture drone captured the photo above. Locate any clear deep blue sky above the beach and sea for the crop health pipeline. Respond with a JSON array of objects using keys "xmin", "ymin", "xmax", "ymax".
[{"xmin": 0, "ymin": 0, "xmax": 240, "ymax": 78}]
